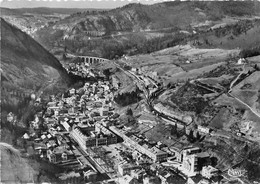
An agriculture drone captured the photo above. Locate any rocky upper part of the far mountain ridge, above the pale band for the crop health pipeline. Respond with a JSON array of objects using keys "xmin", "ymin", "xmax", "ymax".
[{"xmin": 46, "ymin": 2, "xmax": 260, "ymax": 32}]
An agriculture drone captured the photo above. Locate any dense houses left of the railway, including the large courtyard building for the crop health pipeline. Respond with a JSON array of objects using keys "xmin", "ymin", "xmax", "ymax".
[{"xmin": 21, "ymin": 81, "xmax": 117, "ymax": 170}]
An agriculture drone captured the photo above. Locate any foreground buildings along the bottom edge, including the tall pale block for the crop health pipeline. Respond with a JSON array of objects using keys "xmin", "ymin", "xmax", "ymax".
[{"xmin": 112, "ymin": 143, "xmax": 222, "ymax": 184}]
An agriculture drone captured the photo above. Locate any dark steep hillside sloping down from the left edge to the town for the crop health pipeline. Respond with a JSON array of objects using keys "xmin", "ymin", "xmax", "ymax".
[{"xmin": 0, "ymin": 18, "xmax": 71, "ymax": 115}]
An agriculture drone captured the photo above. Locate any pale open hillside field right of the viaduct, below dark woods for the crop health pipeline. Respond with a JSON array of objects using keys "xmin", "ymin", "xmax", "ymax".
[{"xmin": 124, "ymin": 45, "xmax": 239, "ymax": 84}]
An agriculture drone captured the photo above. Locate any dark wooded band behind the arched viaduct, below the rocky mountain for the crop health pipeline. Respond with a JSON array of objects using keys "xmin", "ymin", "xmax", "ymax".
[{"xmin": 64, "ymin": 33, "xmax": 187, "ymax": 59}]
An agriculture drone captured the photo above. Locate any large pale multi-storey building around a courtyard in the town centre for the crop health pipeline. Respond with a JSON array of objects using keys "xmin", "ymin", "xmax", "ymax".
[{"xmin": 71, "ymin": 124, "xmax": 117, "ymax": 149}]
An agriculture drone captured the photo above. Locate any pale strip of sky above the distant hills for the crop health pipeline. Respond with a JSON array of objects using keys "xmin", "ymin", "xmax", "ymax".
[{"xmin": 0, "ymin": 0, "xmax": 161, "ymax": 9}]
